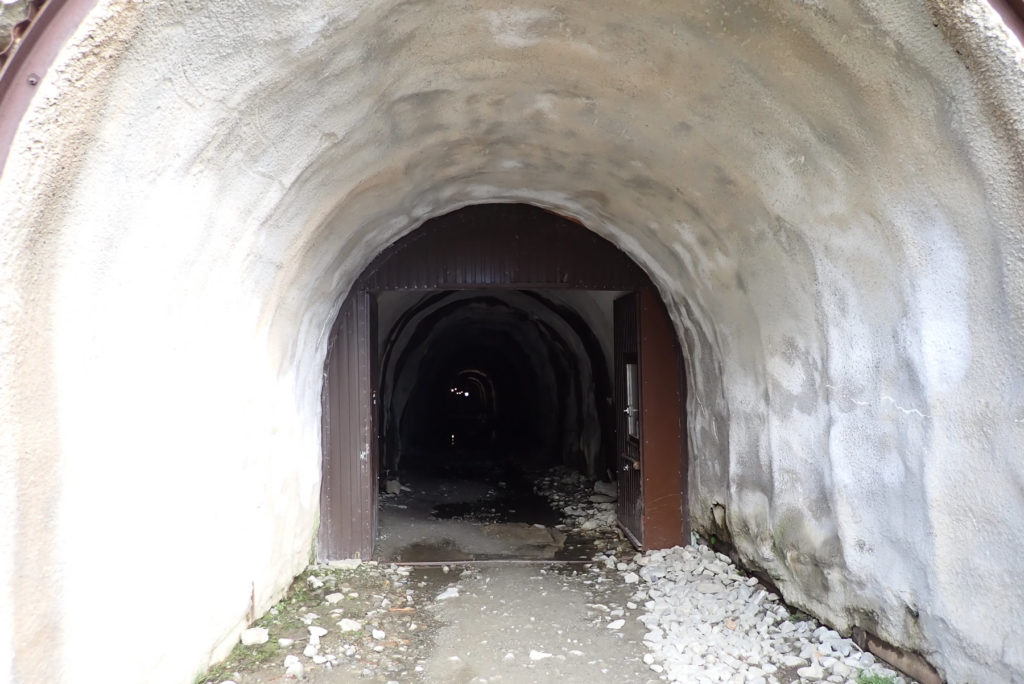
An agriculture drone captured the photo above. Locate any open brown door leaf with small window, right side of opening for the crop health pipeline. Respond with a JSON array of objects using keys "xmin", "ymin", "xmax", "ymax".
[{"xmin": 614, "ymin": 293, "xmax": 643, "ymax": 548}]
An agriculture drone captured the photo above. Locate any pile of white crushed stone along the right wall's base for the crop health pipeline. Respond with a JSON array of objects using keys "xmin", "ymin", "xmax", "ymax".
[{"xmin": 630, "ymin": 546, "xmax": 906, "ymax": 684}]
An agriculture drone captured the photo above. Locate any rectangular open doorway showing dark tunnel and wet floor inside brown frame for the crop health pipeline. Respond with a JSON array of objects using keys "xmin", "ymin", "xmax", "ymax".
[{"xmin": 377, "ymin": 289, "xmax": 622, "ymax": 562}]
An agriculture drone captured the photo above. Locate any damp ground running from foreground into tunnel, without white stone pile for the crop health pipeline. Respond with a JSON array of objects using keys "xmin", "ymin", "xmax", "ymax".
[{"xmin": 197, "ymin": 462, "xmax": 643, "ymax": 684}]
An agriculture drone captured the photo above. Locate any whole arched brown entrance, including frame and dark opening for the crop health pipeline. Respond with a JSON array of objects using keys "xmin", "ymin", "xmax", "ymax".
[{"xmin": 318, "ymin": 205, "xmax": 688, "ymax": 562}]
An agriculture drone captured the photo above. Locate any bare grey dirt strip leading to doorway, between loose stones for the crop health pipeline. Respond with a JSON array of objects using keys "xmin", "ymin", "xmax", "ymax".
[{"xmin": 411, "ymin": 565, "xmax": 657, "ymax": 684}]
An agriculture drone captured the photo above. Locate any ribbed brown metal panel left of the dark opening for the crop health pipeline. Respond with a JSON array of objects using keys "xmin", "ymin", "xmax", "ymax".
[{"xmin": 317, "ymin": 291, "xmax": 377, "ymax": 560}]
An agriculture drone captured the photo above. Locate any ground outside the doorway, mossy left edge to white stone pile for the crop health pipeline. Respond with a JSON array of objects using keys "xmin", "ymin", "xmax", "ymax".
[{"xmin": 198, "ymin": 563, "xmax": 656, "ymax": 684}]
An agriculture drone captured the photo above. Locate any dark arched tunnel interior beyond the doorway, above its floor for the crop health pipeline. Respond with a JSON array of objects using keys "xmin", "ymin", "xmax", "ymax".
[{"xmin": 382, "ymin": 291, "xmax": 612, "ymax": 476}]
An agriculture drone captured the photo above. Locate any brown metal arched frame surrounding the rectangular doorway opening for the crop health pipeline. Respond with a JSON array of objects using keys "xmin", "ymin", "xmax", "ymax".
[{"xmin": 317, "ymin": 204, "xmax": 689, "ymax": 560}]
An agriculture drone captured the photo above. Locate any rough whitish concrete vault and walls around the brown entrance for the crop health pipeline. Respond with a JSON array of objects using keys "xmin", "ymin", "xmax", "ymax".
[{"xmin": 0, "ymin": 0, "xmax": 1024, "ymax": 682}]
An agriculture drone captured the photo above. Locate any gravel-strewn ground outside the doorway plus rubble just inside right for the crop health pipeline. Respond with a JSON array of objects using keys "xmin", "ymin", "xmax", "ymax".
[{"xmin": 197, "ymin": 471, "xmax": 909, "ymax": 684}]
